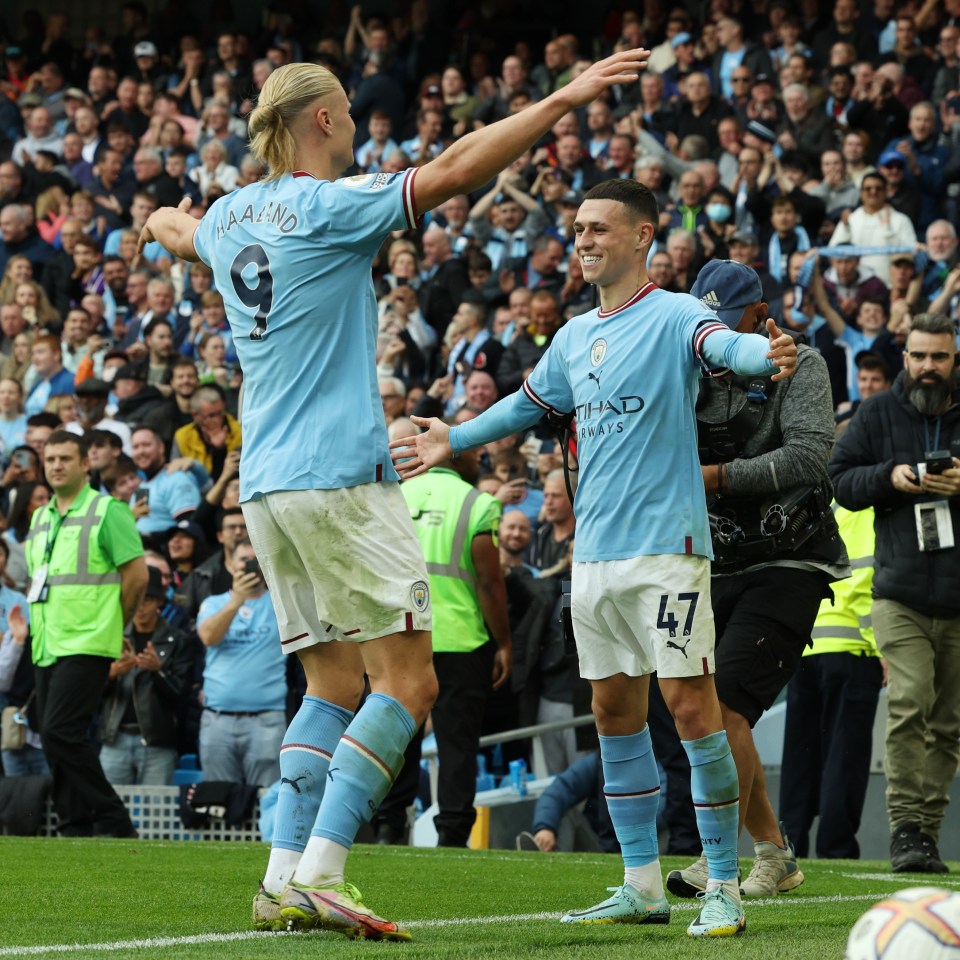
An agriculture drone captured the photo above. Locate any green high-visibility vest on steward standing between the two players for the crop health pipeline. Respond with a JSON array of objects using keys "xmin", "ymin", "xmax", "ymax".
[{"xmin": 400, "ymin": 468, "xmax": 500, "ymax": 653}]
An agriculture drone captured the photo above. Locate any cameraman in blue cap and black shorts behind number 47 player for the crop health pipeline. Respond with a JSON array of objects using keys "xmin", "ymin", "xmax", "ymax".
[{"xmin": 667, "ymin": 260, "xmax": 849, "ymax": 897}]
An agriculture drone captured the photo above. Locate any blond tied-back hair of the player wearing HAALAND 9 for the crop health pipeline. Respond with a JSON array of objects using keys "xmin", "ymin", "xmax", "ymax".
[{"xmin": 249, "ymin": 63, "xmax": 342, "ymax": 180}]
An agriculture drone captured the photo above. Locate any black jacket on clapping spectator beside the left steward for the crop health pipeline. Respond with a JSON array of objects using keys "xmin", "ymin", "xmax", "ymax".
[{"xmin": 100, "ymin": 617, "xmax": 197, "ymax": 747}]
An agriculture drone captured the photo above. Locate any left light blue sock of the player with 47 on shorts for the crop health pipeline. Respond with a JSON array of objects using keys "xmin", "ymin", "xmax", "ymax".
[{"xmin": 600, "ymin": 727, "xmax": 660, "ymax": 867}]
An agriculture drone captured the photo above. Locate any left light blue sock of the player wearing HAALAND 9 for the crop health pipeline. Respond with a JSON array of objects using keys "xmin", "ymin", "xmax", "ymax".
[{"xmin": 272, "ymin": 696, "xmax": 353, "ymax": 853}]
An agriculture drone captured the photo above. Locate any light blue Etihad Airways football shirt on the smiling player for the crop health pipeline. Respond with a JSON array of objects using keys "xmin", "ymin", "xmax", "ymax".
[{"xmin": 450, "ymin": 283, "xmax": 774, "ymax": 561}]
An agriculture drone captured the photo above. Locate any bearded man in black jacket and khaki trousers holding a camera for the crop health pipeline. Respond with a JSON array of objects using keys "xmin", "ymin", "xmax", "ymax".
[{"xmin": 830, "ymin": 313, "xmax": 960, "ymax": 873}]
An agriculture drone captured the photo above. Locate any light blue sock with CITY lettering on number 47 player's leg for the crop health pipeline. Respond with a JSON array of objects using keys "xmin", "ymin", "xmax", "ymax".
[{"xmin": 681, "ymin": 730, "xmax": 740, "ymax": 880}]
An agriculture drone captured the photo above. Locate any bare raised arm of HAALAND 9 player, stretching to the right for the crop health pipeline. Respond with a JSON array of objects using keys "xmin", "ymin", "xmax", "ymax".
[{"xmin": 414, "ymin": 48, "xmax": 650, "ymax": 212}]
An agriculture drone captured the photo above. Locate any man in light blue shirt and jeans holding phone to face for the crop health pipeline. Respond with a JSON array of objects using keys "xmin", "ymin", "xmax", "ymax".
[{"xmin": 197, "ymin": 538, "xmax": 287, "ymax": 787}]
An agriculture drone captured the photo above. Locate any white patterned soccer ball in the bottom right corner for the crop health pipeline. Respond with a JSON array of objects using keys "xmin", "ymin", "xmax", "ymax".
[{"xmin": 844, "ymin": 887, "xmax": 960, "ymax": 960}]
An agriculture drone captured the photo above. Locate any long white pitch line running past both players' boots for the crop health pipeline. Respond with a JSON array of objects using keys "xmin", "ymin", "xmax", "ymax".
[{"xmin": 0, "ymin": 893, "xmax": 916, "ymax": 957}]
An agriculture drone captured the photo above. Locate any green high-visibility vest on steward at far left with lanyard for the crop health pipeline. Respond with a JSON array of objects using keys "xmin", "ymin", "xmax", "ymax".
[{"xmin": 25, "ymin": 485, "xmax": 123, "ymax": 666}]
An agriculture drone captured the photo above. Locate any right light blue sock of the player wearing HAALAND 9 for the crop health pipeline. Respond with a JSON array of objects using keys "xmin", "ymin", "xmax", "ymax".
[{"xmin": 312, "ymin": 693, "xmax": 417, "ymax": 849}]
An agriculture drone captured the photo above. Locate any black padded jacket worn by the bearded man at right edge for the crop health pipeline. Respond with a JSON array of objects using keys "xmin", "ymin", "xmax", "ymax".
[{"xmin": 829, "ymin": 374, "xmax": 960, "ymax": 617}]
